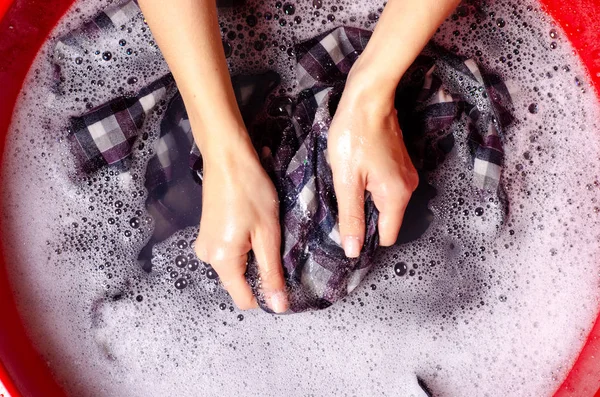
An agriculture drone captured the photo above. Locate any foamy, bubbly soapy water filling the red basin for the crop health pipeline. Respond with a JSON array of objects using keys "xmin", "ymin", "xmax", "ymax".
[{"xmin": 1, "ymin": 0, "xmax": 600, "ymax": 396}]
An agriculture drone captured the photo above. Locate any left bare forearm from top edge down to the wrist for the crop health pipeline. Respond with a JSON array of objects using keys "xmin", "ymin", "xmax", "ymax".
[{"xmin": 139, "ymin": 0, "xmax": 248, "ymax": 154}]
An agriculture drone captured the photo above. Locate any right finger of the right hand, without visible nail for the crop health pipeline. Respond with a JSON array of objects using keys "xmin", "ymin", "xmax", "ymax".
[{"xmin": 373, "ymin": 192, "xmax": 410, "ymax": 247}]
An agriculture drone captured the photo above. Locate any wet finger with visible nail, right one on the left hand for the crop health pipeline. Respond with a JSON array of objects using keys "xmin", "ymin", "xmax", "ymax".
[{"xmin": 252, "ymin": 223, "xmax": 289, "ymax": 313}]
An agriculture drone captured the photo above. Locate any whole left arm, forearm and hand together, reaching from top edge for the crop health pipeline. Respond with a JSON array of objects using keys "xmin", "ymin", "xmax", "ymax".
[{"xmin": 140, "ymin": 0, "xmax": 288, "ymax": 312}]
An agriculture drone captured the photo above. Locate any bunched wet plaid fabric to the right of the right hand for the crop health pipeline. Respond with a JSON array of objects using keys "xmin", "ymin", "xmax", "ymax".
[{"xmin": 396, "ymin": 43, "xmax": 513, "ymax": 192}]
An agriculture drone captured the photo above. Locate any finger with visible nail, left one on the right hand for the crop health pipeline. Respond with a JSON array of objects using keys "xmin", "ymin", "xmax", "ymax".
[{"xmin": 334, "ymin": 178, "xmax": 365, "ymax": 258}]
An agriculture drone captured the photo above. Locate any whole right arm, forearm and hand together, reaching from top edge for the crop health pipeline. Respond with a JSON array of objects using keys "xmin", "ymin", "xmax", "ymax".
[{"xmin": 328, "ymin": 0, "xmax": 459, "ymax": 257}]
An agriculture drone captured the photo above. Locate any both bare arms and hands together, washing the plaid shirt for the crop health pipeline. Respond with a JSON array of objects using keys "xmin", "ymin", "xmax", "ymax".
[{"xmin": 139, "ymin": 0, "xmax": 458, "ymax": 313}]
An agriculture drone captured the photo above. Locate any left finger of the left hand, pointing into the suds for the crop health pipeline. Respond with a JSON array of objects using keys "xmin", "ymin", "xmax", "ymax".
[{"xmin": 211, "ymin": 254, "xmax": 258, "ymax": 310}]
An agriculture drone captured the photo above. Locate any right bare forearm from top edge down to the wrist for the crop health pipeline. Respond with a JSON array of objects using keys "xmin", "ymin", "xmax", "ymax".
[{"xmin": 350, "ymin": 0, "xmax": 460, "ymax": 100}]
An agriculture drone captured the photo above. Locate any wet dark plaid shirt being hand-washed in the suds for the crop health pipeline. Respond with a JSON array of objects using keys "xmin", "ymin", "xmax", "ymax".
[{"xmin": 57, "ymin": 3, "xmax": 512, "ymax": 312}]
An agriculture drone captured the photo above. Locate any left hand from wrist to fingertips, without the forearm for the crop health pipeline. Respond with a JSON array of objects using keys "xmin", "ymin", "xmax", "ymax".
[{"xmin": 195, "ymin": 131, "xmax": 288, "ymax": 313}]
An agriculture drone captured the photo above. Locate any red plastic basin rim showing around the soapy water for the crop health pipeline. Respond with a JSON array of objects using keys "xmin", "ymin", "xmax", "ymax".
[{"xmin": 0, "ymin": 0, "xmax": 600, "ymax": 397}]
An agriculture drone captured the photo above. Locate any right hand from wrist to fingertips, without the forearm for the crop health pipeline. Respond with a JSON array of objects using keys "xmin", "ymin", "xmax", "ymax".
[{"xmin": 328, "ymin": 71, "xmax": 419, "ymax": 258}]
